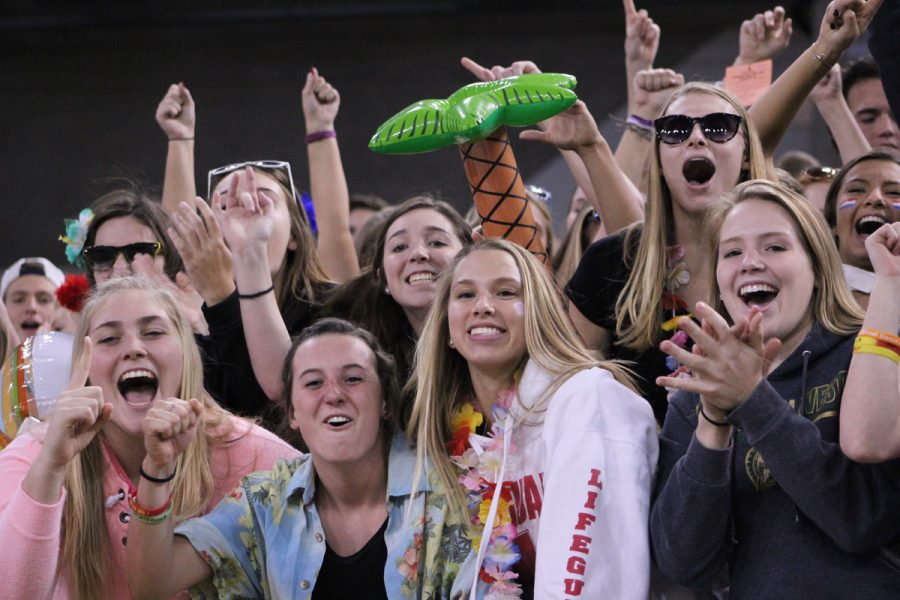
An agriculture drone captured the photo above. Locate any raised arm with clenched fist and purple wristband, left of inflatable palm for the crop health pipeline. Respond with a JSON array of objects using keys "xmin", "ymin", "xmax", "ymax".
[{"xmin": 302, "ymin": 67, "xmax": 359, "ymax": 282}]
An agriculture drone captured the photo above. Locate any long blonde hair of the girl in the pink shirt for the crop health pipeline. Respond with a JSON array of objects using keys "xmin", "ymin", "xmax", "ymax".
[{"xmin": 61, "ymin": 277, "xmax": 231, "ymax": 598}]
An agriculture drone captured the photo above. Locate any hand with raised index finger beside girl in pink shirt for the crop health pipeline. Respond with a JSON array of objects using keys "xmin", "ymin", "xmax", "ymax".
[{"xmin": 22, "ymin": 337, "xmax": 112, "ymax": 504}]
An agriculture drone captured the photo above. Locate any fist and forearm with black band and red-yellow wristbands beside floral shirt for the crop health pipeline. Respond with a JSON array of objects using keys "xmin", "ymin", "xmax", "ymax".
[{"xmin": 125, "ymin": 398, "xmax": 212, "ymax": 599}]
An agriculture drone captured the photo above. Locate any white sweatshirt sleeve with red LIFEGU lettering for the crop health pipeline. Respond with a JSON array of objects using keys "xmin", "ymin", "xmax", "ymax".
[{"xmin": 535, "ymin": 369, "xmax": 658, "ymax": 600}]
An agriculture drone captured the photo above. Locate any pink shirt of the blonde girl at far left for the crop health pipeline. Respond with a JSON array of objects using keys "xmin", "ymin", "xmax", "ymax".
[{"xmin": 0, "ymin": 417, "xmax": 300, "ymax": 600}]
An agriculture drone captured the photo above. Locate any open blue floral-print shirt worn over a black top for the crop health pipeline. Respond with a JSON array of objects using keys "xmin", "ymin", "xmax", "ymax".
[{"xmin": 176, "ymin": 436, "xmax": 471, "ymax": 599}]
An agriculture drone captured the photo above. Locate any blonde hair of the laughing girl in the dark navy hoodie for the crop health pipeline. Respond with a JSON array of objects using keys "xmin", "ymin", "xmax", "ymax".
[{"xmin": 704, "ymin": 180, "xmax": 865, "ymax": 335}]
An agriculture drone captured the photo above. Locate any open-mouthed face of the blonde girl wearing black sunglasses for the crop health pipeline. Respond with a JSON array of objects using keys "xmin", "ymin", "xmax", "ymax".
[{"xmin": 658, "ymin": 92, "xmax": 745, "ymax": 214}]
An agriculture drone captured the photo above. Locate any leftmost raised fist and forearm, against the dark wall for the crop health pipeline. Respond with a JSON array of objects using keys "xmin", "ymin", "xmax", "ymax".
[{"xmin": 156, "ymin": 83, "xmax": 197, "ymax": 214}]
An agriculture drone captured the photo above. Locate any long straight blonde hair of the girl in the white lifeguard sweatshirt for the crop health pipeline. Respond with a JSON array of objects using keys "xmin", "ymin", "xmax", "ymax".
[{"xmin": 406, "ymin": 239, "xmax": 633, "ymax": 518}]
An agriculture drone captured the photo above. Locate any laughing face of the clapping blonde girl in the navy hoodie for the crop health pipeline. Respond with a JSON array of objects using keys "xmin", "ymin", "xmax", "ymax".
[{"xmin": 716, "ymin": 199, "xmax": 815, "ymax": 348}]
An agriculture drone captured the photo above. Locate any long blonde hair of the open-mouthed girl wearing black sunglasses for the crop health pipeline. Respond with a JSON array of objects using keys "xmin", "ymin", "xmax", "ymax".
[{"xmin": 616, "ymin": 82, "xmax": 769, "ymax": 350}]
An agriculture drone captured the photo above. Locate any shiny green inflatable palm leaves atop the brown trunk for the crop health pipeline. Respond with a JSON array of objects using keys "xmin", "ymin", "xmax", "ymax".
[{"xmin": 369, "ymin": 73, "xmax": 578, "ymax": 154}]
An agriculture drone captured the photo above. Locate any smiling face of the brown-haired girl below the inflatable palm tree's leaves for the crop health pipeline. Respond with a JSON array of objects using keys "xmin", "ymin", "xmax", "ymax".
[{"xmin": 382, "ymin": 208, "xmax": 462, "ymax": 331}]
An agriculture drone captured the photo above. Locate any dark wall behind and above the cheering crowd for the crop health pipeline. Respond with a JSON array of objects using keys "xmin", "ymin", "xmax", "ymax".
[{"xmin": 0, "ymin": 0, "xmax": 844, "ymax": 265}]
